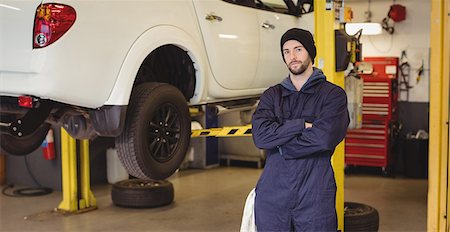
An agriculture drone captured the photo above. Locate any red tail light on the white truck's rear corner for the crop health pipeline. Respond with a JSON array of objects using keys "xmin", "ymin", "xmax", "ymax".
[{"xmin": 33, "ymin": 3, "xmax": 77, "ymax": 48}]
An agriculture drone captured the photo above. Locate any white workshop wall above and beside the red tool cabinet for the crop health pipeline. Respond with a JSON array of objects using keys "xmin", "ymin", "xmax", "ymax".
[{"xmin": 344, "ymin": 0, "xmax": 431, "ymax": 102}]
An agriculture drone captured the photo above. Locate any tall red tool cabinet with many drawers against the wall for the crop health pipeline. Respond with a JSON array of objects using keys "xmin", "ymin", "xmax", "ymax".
[{"xmin": 345, "ymin": 57, "xmax": 398, "ymax": 173}]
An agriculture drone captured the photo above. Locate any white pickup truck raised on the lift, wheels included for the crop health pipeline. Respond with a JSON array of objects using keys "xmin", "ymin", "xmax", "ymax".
[{"xmin": 0, "ymin": 0, "xmax": 314, "ymax": 179}]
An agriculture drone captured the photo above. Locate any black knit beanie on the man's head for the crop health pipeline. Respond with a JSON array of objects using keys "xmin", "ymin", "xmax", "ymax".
[{"xmin": 280, "ymin": 28, "xmax": 316, "ymax": 64}]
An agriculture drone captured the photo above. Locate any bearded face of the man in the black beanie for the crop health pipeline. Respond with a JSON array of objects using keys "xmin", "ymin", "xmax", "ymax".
[{"xmin": 283, "ymin": 40, "xmax": 312, "ymax": 75}]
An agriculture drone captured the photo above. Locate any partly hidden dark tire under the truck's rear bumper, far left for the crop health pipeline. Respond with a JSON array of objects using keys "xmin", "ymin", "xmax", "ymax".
[{"xmin": 0, "ymin": 123, "xmax": 50, "ymax": 156}]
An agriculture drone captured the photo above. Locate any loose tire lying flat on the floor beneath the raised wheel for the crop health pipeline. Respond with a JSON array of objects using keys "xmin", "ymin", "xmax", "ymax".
[{"xmin": 111, "ymin": 179, "xmax": 174, "ymax": 208}]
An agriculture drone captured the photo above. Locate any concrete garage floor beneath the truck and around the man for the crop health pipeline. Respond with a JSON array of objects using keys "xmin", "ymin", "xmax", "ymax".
[{"xmin": 0, "ymin": 167, "xmax": 427, "ymax": 231}]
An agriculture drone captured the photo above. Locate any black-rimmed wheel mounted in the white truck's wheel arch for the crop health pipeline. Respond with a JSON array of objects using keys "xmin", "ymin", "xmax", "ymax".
[{"xmin": 116, "ymin": 83, "xmax": 191, "ymax": 180}]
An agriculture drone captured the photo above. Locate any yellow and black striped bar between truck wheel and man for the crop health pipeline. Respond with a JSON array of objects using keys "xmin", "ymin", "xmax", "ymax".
[{"xmin": 191, "ymin": 125, "xmax": 252, "ymax": 138}]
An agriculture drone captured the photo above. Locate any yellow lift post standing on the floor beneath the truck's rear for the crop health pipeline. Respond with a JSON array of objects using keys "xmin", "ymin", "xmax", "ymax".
[{"xmin": 57, "ymin": 128, "xmax": 97, "ymax": 213}]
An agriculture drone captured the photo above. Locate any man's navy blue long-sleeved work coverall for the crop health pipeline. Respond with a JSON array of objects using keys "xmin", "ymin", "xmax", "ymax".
[{"xmin": 252, "ymin": 68, "xmax": 350, "ymax": 231}]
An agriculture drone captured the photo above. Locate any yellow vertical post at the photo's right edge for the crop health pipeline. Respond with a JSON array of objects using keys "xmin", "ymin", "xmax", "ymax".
[{"xmin": 427, "ymin": 0, "xmax": 450, "ymax": 232}]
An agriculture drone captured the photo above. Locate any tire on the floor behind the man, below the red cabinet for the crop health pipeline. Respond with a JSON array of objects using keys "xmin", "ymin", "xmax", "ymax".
[{"xmin": 344, "ymin": 202, "xmax": 380, "ymax": 231}]
